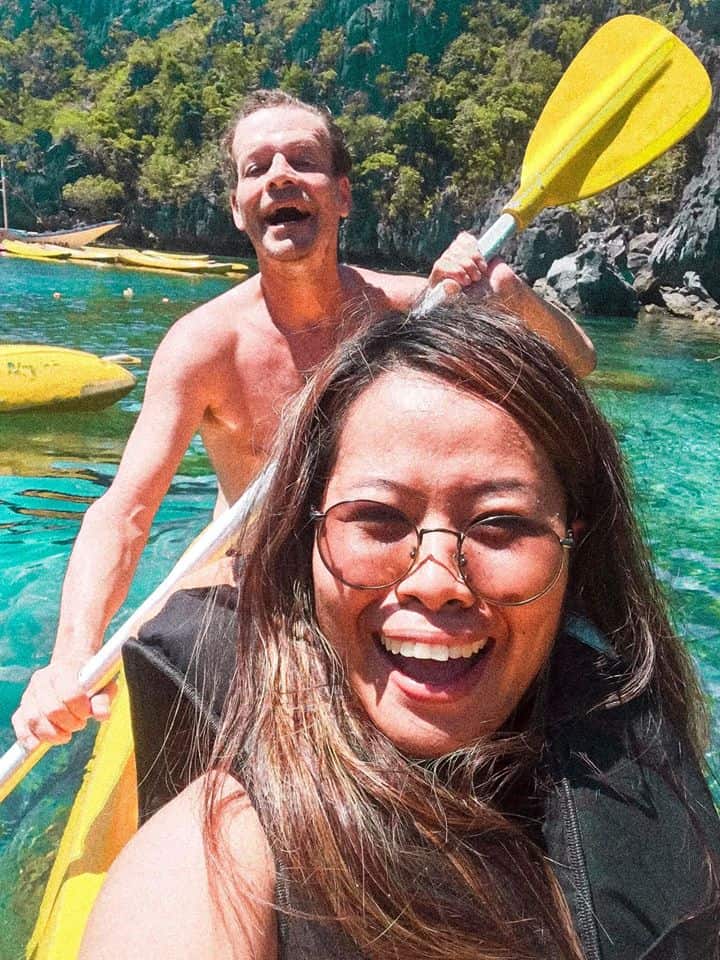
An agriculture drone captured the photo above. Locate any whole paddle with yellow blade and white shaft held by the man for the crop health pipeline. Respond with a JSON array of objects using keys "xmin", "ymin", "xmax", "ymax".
[{"xmin": 0, "ymin": 16, "xmax": 711, "ymax": 801}]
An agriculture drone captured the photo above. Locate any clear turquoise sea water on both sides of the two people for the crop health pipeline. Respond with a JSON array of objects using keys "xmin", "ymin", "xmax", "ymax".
[{"xmin": 0, "ymin": 258, "xmax": 720, "ymax": 960}]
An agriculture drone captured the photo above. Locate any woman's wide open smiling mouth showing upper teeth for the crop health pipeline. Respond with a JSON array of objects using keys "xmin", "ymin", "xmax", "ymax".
[{"xmin": 375, "ymin": 634, "xmax": 494, "ymax": 693}]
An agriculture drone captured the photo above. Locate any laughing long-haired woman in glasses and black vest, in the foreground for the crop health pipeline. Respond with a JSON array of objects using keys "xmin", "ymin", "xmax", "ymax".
[{"xmin": 82, "ymin": 304, "xmax": 720, "ymax": 960}]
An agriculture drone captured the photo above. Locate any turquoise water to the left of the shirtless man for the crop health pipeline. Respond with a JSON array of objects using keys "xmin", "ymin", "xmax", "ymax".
[{"xmin": 0, "ymin": 257, "xmax": 236, "ymax": 960}]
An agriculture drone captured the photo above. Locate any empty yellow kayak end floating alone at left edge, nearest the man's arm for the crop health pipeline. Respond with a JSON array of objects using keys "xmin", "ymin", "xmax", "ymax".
[{"xmin": 0, "ymin": 343, "xmax": 135, "ymax": 413}]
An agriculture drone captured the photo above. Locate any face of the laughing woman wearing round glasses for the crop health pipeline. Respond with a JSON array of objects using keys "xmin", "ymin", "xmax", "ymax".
[{"xmin": 313, "ymin": 369, "xmax": 571, "ymax": 756}]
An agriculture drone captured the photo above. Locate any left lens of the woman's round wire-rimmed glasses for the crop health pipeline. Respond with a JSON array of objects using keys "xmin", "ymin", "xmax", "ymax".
[{"xmin": 317, "ymin": 500, "xmax": 417, "ymax": 587}]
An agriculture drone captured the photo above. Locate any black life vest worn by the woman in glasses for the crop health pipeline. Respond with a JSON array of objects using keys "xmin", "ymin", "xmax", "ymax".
[{"xmin": 124, "ymin": 587, "xmax": 720, "ymax": 960}]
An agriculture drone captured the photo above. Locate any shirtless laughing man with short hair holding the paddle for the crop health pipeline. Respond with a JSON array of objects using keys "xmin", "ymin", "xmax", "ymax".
[{"xmin": 13, "ymin": 91, "xmax": 594, "ymax": 750}]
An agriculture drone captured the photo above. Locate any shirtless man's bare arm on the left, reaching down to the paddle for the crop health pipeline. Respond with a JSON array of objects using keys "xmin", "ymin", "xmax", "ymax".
[{"xmin": 13, "ymin": 321, "xmax": 208, "ymax": 750}]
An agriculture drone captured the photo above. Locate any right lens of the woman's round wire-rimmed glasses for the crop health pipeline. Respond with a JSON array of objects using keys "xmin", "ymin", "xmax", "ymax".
[{"xmin": 462, "ymin": 516, "xmax": 564, "ymax": 604}]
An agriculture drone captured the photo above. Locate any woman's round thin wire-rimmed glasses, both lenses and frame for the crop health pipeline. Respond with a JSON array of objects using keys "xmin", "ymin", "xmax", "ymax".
[{"xmin": 310, "ymin": 500, "xmax": 575, "ymax": 607}]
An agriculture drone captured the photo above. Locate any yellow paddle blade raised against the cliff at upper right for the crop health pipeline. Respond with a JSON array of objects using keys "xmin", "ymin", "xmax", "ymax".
[{"xmin": 505, "ymin": 14, "xmax": 712, "ymax": 229}]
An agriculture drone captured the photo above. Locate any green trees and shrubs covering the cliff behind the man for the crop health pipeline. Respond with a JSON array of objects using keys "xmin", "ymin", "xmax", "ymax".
[{"xmin": 0, "ymin": 0, "xmax": 700, "ymax": 264}]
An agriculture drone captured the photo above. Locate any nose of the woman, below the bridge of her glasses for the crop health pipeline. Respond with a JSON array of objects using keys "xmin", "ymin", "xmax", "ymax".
[{"xmin": 395, "ymin": 530, "xmax": 475, "ymax": 610}]
